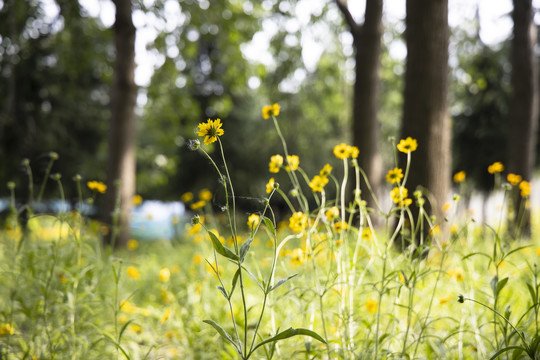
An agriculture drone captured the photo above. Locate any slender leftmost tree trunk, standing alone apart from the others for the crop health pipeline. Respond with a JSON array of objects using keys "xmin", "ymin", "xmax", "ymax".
[{"xmin": 104, "ymin": 0, "xmax": 137, "ymax": 246}]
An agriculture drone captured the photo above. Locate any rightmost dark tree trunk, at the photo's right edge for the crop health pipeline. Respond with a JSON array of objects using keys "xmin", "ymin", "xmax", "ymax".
[{"xmin": 508, "ymin": 0, "xmax": 538, "ymax": 236}]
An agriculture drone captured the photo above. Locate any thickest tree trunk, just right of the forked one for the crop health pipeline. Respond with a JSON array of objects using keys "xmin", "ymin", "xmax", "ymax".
[{"xmin": 401, "ymin": 0, "xmax": 451, "ymax": 228}]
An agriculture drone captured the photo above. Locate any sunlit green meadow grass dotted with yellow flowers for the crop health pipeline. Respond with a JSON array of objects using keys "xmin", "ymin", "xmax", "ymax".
[{"xmin": 0, "ymin": 110, "xmax": 540, "ymax": 359}]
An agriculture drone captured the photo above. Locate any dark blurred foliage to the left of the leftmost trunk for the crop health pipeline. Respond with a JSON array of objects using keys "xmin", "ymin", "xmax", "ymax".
[{"xmin": 0, "ymin": 0, "xmax": 111, "ymax": 200}]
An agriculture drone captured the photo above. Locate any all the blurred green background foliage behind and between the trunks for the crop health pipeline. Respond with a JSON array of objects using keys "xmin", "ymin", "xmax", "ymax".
[{"xmin": 0, "ymin": 0, "xmax": 536, "ymax": 205}]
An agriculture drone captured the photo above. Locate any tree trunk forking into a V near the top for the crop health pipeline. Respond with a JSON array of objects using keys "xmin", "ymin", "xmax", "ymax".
[{"xmin": 336, "ymin": 0, "xmax": 383, "ymax": 211}]
